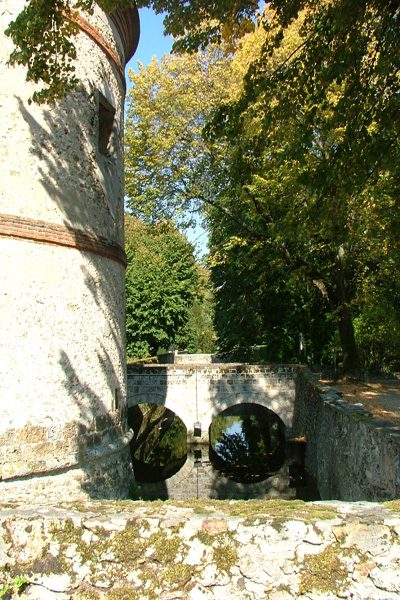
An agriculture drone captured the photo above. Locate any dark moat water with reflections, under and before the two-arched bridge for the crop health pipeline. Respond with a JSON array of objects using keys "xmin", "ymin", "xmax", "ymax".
[{"xmin": 131, "ymin": 405, "xmax": 319, "ymax": 500}]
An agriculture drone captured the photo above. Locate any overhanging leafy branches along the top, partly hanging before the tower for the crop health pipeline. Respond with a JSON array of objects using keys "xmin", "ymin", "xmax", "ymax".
[{"xmin": 6, "ymin": 0, "xmax": 258, "ymax": 103}]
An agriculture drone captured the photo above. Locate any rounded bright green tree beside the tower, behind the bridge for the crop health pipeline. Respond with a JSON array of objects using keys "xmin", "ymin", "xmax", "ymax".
[{"xmin": 125, "ymin": 216, "xmax": 198, "ymax": 358}]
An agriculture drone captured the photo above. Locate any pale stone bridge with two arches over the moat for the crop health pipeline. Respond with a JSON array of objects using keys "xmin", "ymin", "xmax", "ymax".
[{"xmin": 127, "ymin": 364, "xmax": 298, "ymax": 443}]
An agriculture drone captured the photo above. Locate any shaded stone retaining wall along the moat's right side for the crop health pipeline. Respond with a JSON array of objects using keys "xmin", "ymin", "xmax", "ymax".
[{"xmin": 293, "ymin": 371, "xmax": 400, "ymax": 501}]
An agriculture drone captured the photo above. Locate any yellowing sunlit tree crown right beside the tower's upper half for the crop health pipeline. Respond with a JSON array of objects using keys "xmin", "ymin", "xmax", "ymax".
[{"xmin": 125, "ymin": 50, "xmax": 229, "ymax": 225}]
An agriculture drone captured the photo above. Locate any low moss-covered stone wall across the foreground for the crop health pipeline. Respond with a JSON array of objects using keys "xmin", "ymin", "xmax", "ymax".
[{"xmin": 0, "ymin": 501, "xmax": 400, "ymax": 600}]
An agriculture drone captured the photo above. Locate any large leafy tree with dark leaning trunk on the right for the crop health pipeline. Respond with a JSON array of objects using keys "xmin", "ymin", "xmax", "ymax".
[{"xmin": 206, "ymin": 0, "xmax": 400, "ymax": 373}]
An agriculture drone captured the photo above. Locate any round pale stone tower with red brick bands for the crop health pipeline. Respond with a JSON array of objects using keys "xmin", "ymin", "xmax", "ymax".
[{"xmin": 0, "ymin": 0, "xmax": 139, "ymax": 501}]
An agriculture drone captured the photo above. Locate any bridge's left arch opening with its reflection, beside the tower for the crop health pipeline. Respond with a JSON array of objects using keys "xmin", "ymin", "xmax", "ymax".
[{"xmin": 128, "ymin": 404, "xmax": 187, "ymax": 483}]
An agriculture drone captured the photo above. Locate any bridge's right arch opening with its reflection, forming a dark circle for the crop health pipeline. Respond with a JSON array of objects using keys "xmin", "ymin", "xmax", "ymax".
[{"xmin": 209, "ymin": 403, "xmax": 285, "ymax": 483}]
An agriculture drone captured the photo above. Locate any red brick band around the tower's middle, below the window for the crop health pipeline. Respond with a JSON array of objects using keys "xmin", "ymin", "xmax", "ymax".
[{"xmin": 0, "ymin": 214, "xmax": 126, "ymax": 267}]
